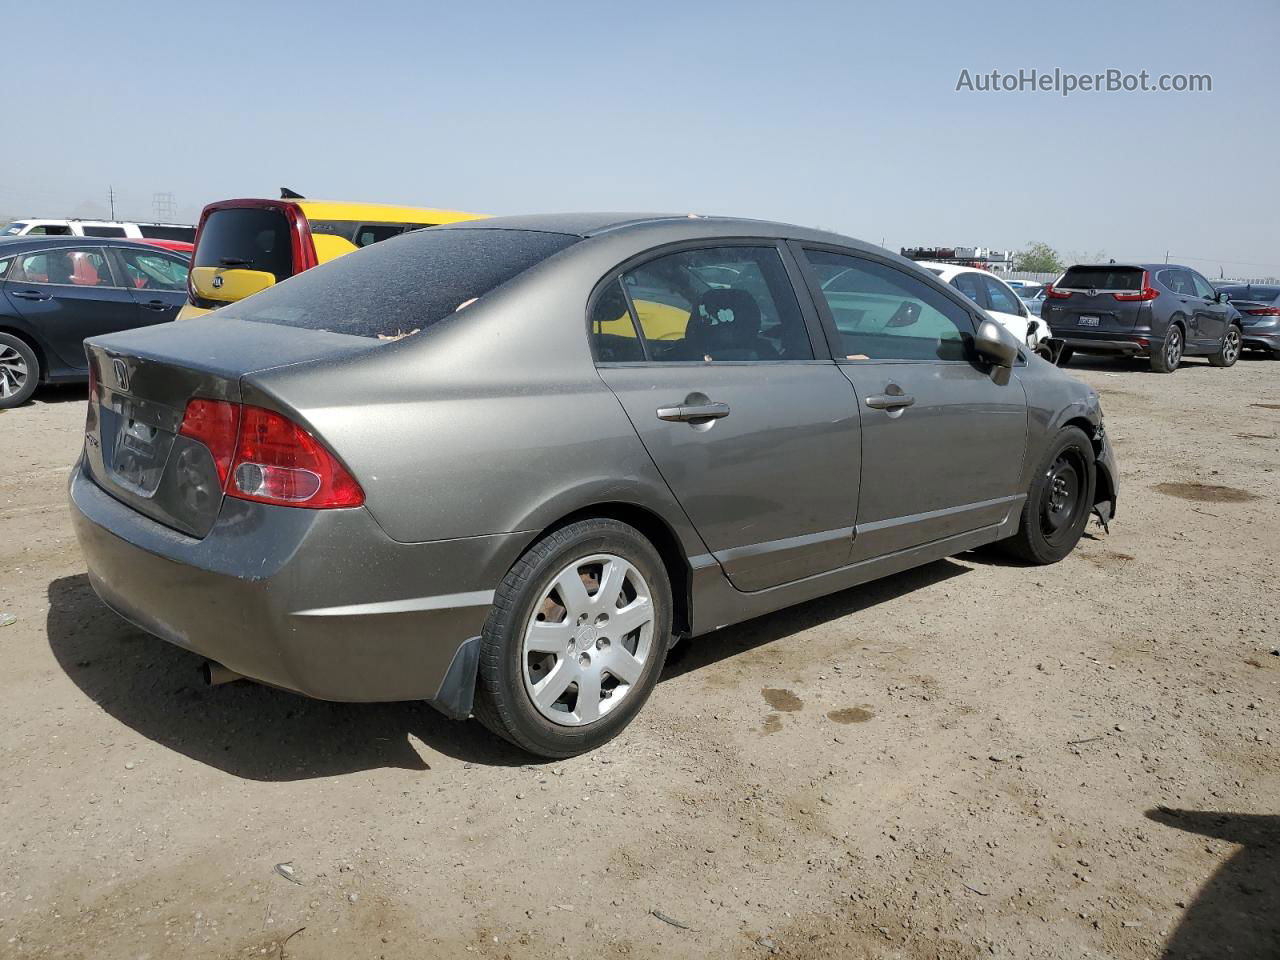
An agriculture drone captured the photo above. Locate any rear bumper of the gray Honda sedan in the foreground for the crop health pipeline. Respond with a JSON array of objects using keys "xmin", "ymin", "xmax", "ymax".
[{"xmin": 70, "ymin": 467, "xmax": 527, "ymax": 714}]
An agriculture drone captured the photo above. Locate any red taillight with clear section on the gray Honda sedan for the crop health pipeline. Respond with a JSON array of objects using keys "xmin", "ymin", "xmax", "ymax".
[{"xmin": 182, "ymin": 398, "xmax": 365, "ymax": 509}]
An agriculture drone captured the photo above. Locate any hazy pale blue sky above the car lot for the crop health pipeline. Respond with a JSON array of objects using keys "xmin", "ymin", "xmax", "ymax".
[{"xmin": 0, "ymin": 0, "xmax": 1280, "ymax": 276}]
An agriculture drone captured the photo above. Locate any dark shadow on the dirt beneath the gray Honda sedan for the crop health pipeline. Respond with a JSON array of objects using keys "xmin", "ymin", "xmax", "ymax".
[{"xmin": 46, "ymin": 561, "xmax": 968, "ymax": 781}]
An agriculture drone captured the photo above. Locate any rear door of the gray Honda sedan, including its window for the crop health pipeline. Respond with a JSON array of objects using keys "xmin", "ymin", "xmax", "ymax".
[{"xmin": 591, "ymin": 241, "xmax": 861, "ymax": 590}]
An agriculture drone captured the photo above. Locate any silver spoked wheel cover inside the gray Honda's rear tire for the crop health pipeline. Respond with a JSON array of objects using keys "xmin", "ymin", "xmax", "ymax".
[{"xmin": 520, "ymin": 553, "xmax": 654, "ymax": 727}]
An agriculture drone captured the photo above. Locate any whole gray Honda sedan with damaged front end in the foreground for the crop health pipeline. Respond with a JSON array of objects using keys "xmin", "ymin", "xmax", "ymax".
[{"xmin": 70, "ymin": 214, "xmax": 1116, "ymax": 756}]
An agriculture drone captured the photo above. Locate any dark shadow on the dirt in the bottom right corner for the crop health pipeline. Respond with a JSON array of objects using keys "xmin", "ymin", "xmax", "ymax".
[{"xmin": 1147, "ymin": 806, "xmax": 1280, "ymax": 960}]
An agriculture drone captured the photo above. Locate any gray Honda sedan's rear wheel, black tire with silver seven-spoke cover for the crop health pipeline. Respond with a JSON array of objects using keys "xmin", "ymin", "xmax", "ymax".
[{"xmin": 474, "ymin": 520, "xmax": 672, "ymax": 759}]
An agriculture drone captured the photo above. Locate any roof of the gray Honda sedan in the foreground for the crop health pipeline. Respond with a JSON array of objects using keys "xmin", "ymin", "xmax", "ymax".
[{"xmin": 433, "ymin": 212, "xmax": 900, "ymax": 249}]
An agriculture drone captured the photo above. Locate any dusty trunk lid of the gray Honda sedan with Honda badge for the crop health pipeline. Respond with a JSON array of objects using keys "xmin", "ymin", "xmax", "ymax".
[{"xmin": 84, "ymin": 320, "xmax": 380, "ymax": 538}]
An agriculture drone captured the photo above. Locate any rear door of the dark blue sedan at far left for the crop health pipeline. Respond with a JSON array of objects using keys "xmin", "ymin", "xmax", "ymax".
[{"xmin": 5, "ymin": 248, "xmax": 138, "ymax": 370}]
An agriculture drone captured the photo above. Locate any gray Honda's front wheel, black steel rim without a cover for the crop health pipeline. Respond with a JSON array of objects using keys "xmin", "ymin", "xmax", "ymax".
[{"xmin": 1001, "ymin": 426, "xmax": 1097, "ymax": 564}]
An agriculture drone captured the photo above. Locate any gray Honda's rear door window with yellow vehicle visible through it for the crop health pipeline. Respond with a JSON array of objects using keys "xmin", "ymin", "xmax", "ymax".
[{"xmin": 606, "ymin": 246, "xmax": 813, "ymax": 362}]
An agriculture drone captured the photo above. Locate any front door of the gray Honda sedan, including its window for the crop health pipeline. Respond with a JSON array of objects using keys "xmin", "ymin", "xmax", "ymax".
[{"xmin": 799, "ymin": 246, "xmax": 1027, "ymax": 561}]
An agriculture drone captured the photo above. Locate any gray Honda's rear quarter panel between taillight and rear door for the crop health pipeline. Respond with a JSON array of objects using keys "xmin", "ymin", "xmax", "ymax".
[{"xmin": 243, "ymin": 248, "xmax": 705, "ymax": 556}]
